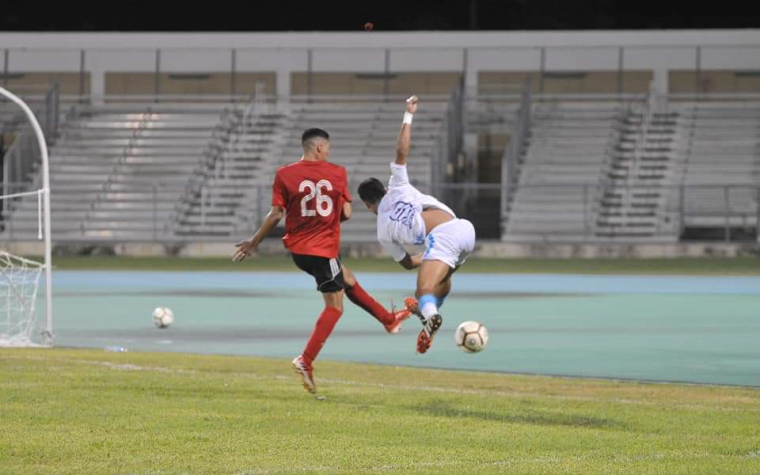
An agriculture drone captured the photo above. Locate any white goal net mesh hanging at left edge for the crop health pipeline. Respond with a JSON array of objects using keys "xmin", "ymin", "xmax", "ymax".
[{"xmin": 0, "ymin": 250, "xmax": 45, "ymax": 346}]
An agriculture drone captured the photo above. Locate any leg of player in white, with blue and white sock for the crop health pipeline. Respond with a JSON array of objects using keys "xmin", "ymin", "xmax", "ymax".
[{"xmin": 416, "ymin": 260, "xmax": 451, "ymax": 353}]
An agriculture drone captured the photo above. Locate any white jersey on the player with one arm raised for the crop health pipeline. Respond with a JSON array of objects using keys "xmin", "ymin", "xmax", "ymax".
[{"xmin": 377, "ymin": 163, "xmax": 456, "ymax": 262}]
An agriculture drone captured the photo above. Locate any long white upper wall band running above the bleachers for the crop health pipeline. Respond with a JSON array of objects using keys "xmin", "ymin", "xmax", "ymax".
[{"xmin": 0, "ymin": 30, "xmax": 760, "ymax": 95}]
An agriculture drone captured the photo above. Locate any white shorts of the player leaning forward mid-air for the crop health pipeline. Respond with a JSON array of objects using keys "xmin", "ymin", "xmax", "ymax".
[{"xmin": 422, "ymin": 219, "xmax": 475, "ymax": 268}]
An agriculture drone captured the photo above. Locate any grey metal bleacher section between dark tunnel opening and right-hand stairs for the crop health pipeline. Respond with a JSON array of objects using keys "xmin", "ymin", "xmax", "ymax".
[{"xmin": 504, "ymin": 102, "xmax": 627, "ymax": 241}]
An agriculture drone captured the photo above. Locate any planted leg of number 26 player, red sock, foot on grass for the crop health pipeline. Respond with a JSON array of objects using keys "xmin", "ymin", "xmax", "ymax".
[{"xmin": 293, "ymin": 290, "xmax": 343, "ymax": 393}]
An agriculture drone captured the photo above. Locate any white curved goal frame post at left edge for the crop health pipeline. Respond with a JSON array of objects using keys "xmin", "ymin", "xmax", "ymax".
[{"xmin": 0, "ymin": 87, "xmax": 53, "ymax": 345}]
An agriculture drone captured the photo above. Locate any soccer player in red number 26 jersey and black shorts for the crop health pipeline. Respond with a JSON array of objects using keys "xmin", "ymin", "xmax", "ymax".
[{"xmin": 232, "ymin": 129, "xmax": 410, "ymax": 393}]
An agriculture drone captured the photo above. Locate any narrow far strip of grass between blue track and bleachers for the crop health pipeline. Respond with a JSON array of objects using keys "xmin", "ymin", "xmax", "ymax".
[{"xmin": 43, "ymin": 256, "xmax": 760, "ymax": 275}]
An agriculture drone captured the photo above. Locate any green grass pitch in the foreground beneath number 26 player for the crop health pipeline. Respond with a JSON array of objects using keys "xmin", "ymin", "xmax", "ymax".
[{"xmin": 0, "ymin": 349, "xmax": 760, "ymax": 475}]
